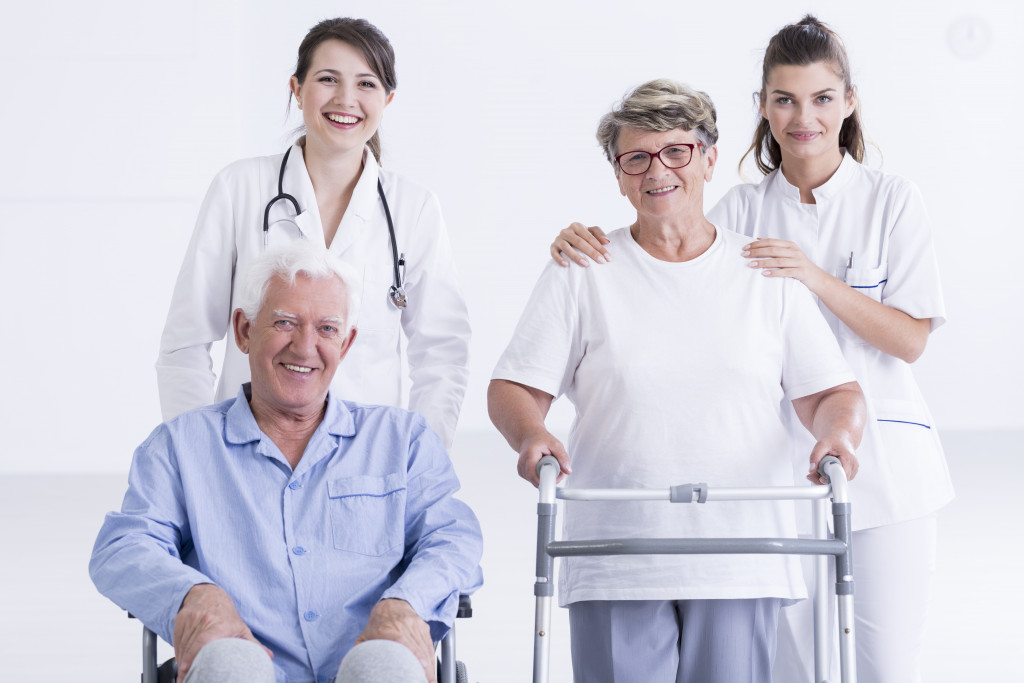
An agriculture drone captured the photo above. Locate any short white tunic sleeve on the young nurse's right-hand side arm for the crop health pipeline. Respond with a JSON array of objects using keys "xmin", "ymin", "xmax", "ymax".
[{"xmin": 882, "ymin": 180, "xmax": 946, "ymax": 330}]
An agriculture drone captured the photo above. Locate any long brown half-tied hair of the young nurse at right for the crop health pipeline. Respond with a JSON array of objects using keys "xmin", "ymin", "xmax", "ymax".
[{"xmin": 739, "ymin": 14, "xmax": 864, "ymax": 175}]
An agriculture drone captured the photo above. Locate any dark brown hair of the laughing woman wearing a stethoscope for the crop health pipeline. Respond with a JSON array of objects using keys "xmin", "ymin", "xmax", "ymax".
[{"xmin": 289, "ymin": 16, "xmax": 398, "ymax": 164}]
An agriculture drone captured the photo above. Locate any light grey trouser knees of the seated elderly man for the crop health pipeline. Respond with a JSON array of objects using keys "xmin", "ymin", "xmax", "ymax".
[{"xmin": 185, "ymin": 638, "xmax": 427, "ymax": 683}]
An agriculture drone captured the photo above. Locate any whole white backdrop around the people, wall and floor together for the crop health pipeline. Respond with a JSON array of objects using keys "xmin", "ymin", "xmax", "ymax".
[{"xmin": 0, "ymin": 0, "xmax": 1024, "ymax": 683}]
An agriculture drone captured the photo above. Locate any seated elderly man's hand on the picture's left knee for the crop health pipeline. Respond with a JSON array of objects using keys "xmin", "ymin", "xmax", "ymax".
[{"xmin": 174, "ymin": 584, "xmax": 273, "ymax": 683}]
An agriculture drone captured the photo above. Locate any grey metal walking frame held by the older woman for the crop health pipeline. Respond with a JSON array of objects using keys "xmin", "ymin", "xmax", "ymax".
[{"xmin": 534, "ymin": 456, "xmax": 857, "ymax": 683}]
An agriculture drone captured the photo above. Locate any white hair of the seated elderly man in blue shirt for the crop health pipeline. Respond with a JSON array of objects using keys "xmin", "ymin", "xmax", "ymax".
[{"xmin": 238, "ymin": 240, "xmax": 362, "ymax": 334}]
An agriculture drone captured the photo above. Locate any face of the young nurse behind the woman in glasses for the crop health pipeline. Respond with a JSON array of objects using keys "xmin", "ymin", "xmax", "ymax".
[{"xmin": 761, "ymin": 61, "xmax": 855, "ymax": 166}]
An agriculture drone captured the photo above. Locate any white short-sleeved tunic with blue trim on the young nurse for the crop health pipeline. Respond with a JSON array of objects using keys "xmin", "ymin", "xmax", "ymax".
[{"xmin": 708, "ymin": 155, "xmax": 953, "ymax": 529}]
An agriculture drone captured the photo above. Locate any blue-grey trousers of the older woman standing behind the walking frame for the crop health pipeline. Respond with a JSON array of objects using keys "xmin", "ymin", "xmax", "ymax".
[{"xmin": 569, "ymin": 598, "xmax": 781, "ymax": 683}]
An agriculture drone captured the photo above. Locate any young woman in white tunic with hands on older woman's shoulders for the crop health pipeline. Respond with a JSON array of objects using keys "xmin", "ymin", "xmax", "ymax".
[{"xmin": 551, "ymin": 15, "xmax": 953, "ymax": 683}]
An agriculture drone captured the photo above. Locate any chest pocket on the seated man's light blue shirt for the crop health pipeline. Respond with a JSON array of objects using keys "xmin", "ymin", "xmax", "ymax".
[{"xmin": 328, "ymin": 473, "xmax": 406, "ymax": 556}]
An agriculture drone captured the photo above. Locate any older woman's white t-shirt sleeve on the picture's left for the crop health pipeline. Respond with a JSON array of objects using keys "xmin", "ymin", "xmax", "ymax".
[{"xmin": 490, "ymin": 262, "xmax": 583, "ymax": 398}]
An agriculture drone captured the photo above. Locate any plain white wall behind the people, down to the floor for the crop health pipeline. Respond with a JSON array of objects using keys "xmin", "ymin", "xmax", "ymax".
[{"xmin": 0, "ymin": 0, "xmax": 1024, "ymax": 472}]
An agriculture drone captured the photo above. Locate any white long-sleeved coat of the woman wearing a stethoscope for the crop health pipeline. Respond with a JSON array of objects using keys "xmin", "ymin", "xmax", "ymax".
[{"xmin": 157, "ymin": 144, "xmax": 470, "ymax": 446}]
